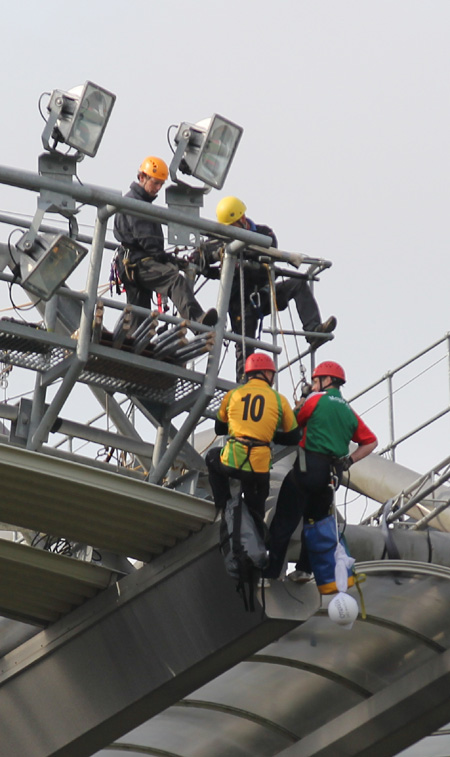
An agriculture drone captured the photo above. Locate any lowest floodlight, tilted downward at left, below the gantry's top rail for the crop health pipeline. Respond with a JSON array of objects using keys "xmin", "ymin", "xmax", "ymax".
[{"xmin": 20, "ymin": 234, "xmax": 87, "ymax": 301}]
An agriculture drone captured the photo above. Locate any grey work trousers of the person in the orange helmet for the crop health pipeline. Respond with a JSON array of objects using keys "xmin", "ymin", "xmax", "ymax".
[{"xmin": 119, "ymin": 258, "xmax": 203, "ymax": 331}]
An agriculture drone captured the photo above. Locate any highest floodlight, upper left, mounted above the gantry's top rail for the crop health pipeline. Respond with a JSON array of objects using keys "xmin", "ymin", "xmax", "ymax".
[{"xmin": 42, "ymin": 81, "xmax": 116, "ymax": 158}]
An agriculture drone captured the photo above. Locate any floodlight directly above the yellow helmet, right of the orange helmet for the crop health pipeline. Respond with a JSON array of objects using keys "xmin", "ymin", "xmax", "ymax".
[{"xmin": 175, "ymin": 114, "xmax": 244, "ymax": 189}]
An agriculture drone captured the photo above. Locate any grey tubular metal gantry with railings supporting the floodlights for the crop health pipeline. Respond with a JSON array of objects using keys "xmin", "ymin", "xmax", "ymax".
[{"xmin": 0, "ymin": 162, "xmax": 332, "ymax": 490}]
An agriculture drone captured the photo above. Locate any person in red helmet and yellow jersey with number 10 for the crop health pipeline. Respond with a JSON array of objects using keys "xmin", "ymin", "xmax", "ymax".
[{"xmin": 206, "ymin": 352, "xmax": 300, "ymax": 524}]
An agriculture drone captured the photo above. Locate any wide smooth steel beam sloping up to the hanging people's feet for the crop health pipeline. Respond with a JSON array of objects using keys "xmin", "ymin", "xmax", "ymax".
[{"xmin": 0, "ymin": 527, "xmax": 317, "ymax": 757}]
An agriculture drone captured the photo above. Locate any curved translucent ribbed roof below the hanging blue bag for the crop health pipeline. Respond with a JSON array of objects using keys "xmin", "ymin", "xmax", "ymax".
[{"xmin": 98, "ymin": 560, "xmax": 450, "ymax": 757}]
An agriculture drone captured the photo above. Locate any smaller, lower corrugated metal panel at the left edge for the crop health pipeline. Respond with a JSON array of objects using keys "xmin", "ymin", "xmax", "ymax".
[{"xmin": 0, "ymin": 539, "xmax": 113, "ymax": 625}]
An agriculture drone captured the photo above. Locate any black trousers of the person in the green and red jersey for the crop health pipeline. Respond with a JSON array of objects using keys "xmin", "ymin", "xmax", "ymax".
[{"xmin": 264, "ymin": 450, "xmax": 342, "ymax": 578}]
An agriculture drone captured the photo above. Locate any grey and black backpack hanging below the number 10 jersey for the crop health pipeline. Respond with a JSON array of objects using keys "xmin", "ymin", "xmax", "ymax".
[{"xmin": 220, "ymin": 493, "xmax": 268, "ymax": 611}]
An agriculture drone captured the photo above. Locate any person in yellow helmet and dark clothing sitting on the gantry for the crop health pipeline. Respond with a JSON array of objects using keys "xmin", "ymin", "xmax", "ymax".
[{"xmin": 202, "ymin": 196, "xmax": 336, "ymax": 382}]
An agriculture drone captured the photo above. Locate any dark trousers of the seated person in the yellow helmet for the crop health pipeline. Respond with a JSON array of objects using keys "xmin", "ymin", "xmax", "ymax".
[{"xmin": 229, "ymin": 279, "xmax": 321, "ymax": 382}]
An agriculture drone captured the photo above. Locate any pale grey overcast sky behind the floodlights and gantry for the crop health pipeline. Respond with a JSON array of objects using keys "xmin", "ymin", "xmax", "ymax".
[{"xmin": 0, "ymin": 0, "xmax": 450, "ymax": 496}]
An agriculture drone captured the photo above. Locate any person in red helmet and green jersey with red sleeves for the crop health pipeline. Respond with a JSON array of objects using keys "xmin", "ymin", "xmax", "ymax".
[{"xmin": 265, "ymin": 360, "xmax": 378, "ymax": 578}]
